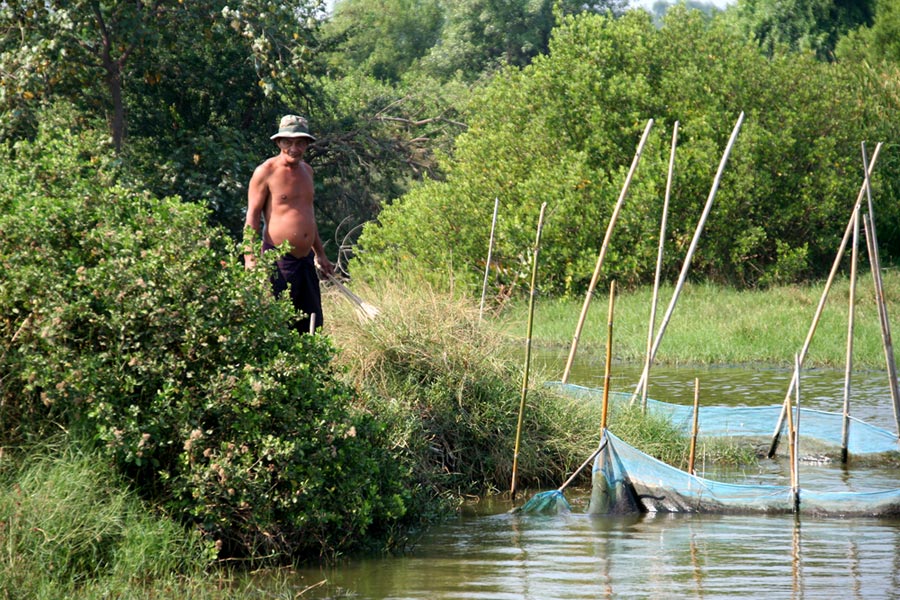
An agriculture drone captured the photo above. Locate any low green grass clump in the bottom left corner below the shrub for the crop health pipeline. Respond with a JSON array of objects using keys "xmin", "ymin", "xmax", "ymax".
[{"xmin": 0, "ymin": 443, "xmax": 215, "ymax": 598}]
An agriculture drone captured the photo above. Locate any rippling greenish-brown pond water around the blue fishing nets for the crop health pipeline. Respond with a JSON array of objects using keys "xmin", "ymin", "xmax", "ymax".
[{"xmin": 297, "ymin": 353, "xmax": 900, "ymax": 600}]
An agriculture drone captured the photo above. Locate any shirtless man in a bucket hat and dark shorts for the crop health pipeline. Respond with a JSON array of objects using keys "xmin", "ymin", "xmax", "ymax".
[{"xmin": 244, "ymin": 115, "xmax": 334, "ymax": 333}]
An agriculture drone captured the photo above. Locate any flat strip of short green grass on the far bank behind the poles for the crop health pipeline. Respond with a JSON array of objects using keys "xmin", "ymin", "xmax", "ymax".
[{"xmin": 494, "ymin": 269, "xmax": 900, "ymax": 368}]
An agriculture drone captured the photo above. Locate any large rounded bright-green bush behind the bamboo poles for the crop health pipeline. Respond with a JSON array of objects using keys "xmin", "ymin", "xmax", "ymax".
[{"xmin": 352, "ymin": 9, "xmax": 897, "ymax": 292}]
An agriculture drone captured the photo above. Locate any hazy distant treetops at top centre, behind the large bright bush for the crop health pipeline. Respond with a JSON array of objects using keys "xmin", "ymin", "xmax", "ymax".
[{"xmin": 326, "ymin": 0, "xmax": 627, "ymax": 82}]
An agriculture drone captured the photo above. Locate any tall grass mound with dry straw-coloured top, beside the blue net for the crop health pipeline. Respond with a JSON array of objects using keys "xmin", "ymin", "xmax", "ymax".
[{"xmin": 329, "ymin": 281, "xmax": 599, "ymax": 497}]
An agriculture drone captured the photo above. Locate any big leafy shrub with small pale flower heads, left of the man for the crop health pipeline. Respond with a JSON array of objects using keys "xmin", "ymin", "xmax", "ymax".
[{"xmin": 0, "ymin": 108, "xmax": 409, "ymax": 558}]
